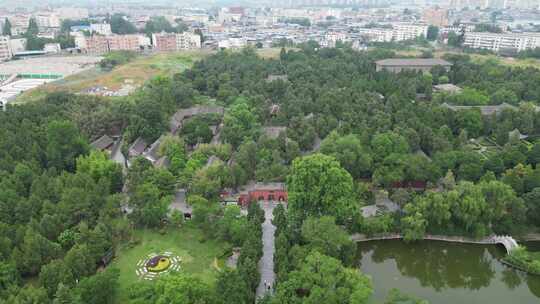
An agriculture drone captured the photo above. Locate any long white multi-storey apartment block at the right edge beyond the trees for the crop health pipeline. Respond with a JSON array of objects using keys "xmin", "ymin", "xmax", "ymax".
[{"xmin": 463, "ymin": 32, "xmax": 540, "ymax": 52}]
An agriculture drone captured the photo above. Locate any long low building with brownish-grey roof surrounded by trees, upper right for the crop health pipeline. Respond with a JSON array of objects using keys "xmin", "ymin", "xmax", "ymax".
[{"xmin": 375, "ymin": 58, "xmax": 452, "ymax": 73}]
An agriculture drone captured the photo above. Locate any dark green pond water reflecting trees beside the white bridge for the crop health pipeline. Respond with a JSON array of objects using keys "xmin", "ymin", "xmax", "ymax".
[{"xmin": 358, "ymin": 240, "xmax": 540, "ymax": 304}]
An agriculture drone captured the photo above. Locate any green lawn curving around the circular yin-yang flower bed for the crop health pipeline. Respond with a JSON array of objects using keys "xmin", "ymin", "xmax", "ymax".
[{"xmin": 109, "ymin": 223, "xmax": 228, "ymax": 303}]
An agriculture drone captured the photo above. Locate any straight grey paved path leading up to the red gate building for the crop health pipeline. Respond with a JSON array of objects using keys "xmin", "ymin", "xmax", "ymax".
[{"xmin": 257, "ymin": 202, "xmax": 276, "ymax": 298}]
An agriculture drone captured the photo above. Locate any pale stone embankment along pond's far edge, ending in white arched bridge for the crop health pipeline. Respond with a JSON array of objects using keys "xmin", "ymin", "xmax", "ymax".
[{"xmin": 351, "ymin": 233, "xmax": 519, "ymax": 254}]
